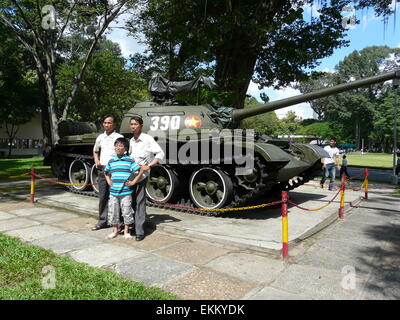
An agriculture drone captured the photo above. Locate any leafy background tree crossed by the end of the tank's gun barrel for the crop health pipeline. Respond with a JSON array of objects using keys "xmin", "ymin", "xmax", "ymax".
[{"xmin": 297, "ymin": 46, "xmax": 400, "ymax": 148}]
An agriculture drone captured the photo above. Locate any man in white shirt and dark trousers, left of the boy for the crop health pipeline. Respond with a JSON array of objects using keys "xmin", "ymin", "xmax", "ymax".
[{"xmin": 92, "ymin": 114, "xmax": 123, "ymax": 231}]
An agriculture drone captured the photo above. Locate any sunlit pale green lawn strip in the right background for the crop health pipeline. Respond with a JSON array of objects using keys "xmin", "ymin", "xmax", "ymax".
[{"xmin": 340, "ymin": 153, "xmax": 393, "ymax": 169}]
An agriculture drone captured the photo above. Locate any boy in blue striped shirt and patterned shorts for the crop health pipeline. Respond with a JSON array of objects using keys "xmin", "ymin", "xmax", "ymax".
[{"xmin": 104, "ymin": 138, "xmax": 144, "ymax": 240}]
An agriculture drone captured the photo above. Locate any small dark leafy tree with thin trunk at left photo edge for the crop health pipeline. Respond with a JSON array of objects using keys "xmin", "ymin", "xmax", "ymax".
[{"xmin": 0, "ymin": 25, "xmax": 39, "ymax": 156}]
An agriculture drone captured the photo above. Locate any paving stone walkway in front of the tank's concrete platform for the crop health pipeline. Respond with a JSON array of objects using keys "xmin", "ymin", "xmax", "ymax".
[{"xmin": 0, "ymin": 188, "xmax": 400, "ymax": 300}]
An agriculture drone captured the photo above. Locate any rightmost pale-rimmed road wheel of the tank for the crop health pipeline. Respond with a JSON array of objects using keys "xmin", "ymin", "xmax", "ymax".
[{"xmin": 189, "ymin": 168, "xmax": 233, "ymax": 209}]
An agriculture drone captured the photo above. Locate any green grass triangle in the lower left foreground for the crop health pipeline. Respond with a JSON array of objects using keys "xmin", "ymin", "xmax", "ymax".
[{"xmin": 0, "ymin": 233, "xmax": 179, "ymax": 300}]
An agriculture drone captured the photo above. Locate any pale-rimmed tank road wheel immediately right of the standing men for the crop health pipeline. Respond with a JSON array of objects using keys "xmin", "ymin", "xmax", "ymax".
[{"xmin": 146, "ymin": 166, "xmax": 179, "ymax": 202}]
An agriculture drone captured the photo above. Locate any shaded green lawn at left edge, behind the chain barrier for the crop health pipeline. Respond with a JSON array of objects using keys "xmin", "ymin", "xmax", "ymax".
[{"xmin": 0, "ymin": 157, "xmax": 53, "ymax": 182}]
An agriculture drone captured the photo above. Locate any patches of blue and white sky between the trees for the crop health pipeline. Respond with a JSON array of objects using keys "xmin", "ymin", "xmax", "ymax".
[{"xmin": 107, "ymin": 0, "xmax": 400, "ymax": 119}]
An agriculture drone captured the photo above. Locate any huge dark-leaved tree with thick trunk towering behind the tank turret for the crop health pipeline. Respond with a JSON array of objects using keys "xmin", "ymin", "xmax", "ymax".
[{"xmin": 129, "ymin": 0, "xmax": 392, "ymax": 108}]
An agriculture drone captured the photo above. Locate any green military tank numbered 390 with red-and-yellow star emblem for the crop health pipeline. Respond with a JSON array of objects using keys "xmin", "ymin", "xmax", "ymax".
[{"xmin": 44, "ymin": 70, "xmax": 400, "ymax": 213}]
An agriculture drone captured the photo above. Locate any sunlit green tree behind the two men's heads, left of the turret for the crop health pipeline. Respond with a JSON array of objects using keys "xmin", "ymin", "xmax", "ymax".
[{"xmin": 56, "ymin": 40, "xmax": 147, "ymax": 122}]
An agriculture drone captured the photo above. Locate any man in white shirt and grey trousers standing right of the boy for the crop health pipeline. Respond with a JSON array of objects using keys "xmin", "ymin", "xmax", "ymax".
[{"xmin": 129, "ymin": 116, "xmax": 164, "ymax": 241}]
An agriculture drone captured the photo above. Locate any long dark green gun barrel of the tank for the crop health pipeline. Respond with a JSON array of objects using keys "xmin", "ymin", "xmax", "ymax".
[{"xmin": 231, "ymin": 69, "xmax": 400, "ymax": 120}]
